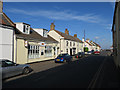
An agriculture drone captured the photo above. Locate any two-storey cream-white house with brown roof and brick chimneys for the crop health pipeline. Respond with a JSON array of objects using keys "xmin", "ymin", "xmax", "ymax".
[{"xmin": 48, "ymin": 23, "xmax": 83, "ymax": 55}]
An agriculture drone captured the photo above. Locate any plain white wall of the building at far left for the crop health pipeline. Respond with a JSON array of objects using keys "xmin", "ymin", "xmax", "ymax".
[{"xmin": 0, "ymin": 26, "xmax": 14, "ymax": 61}]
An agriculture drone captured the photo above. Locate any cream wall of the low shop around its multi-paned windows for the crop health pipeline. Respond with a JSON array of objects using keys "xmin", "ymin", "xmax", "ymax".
[{"xmin": 16, "ymin": 39, "xmax": 57, "ymax": 64}]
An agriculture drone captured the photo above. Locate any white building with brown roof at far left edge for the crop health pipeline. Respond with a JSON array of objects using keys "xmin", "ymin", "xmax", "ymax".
[{"xmin": 0, "ymin": 12, "xmax": 15, "ymax": 61}]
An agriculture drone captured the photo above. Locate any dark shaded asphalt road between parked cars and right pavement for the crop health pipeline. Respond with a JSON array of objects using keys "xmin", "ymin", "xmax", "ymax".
[{"xmin": 3, "ymin": 54, "xmax": 106, "ymax": 88}]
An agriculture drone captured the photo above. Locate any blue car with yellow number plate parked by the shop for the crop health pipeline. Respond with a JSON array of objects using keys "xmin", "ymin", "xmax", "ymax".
[{"xmin": 55, "ymin": 54, "xmax": 72, "ymax": 63}]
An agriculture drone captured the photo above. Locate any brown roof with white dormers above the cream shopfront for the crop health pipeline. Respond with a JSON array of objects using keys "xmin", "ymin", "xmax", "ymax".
[{"xmin": 16, "ymin": 28, "xmax": 57, "ymax": 43}]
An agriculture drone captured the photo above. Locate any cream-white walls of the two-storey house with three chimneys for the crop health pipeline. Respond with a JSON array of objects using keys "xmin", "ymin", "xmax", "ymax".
[{"xmin": 48, "ymin": 30, "xmax": 83, "ymax": 55}]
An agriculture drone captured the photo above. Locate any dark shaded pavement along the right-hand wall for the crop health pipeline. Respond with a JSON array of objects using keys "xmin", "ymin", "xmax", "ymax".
[{"xmin": 89, "ymin": 56, "xmax": 120, "ymax": 88}]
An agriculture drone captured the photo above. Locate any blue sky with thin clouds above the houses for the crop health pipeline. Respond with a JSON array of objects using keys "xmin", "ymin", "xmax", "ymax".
[{"xmin": 3, "ymin": 2, "xmax": 114, "ymax": 49}]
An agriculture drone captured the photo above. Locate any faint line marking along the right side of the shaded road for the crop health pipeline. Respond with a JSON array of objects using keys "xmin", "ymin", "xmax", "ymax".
[{"xmin": 88, "ymin": 57, "xmax": 107, "ymax": 89}]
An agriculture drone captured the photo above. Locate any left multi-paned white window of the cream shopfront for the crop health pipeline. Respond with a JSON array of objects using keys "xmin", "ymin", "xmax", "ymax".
[{"xmin": 28, "ymin": 45, "xmax": 40, "ymax": 59}]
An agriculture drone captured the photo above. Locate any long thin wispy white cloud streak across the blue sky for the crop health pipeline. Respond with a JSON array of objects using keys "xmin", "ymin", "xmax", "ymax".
[{"xmin": 8, "ymin": 9, "xmax": 104, "ymax": 23}]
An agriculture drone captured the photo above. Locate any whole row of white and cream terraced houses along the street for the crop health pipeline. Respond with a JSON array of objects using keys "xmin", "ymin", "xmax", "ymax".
[{"xmin": 0, "ymin": 2, "xmax": 101, "ymax": 64}]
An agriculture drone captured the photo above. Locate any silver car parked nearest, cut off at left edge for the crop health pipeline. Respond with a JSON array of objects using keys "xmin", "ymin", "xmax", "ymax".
[{"xmin": 0, "ymin": 59, "xmax": 32, "ymax": 79}]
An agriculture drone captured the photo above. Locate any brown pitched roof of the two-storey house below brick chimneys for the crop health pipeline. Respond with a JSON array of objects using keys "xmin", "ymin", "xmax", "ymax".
[{"xmin": 51, "ymin": 30, "xmax": 83, "ymax": 43}]
